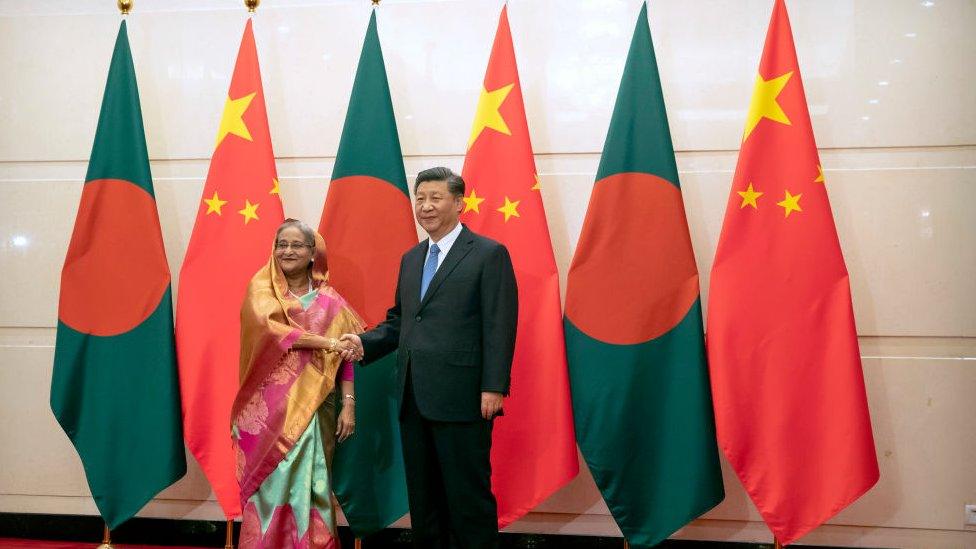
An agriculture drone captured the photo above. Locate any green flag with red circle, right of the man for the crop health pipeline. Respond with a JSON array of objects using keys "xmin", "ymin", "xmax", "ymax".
[{"xmin": 565, "ymin": 5, "xmax": 724, "ymax": 546}]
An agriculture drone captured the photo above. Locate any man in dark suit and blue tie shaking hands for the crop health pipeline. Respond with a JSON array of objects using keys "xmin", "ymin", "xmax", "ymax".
[{"xmin": 342, "ymin": 168, "xmax": 518, "ymax": 549}]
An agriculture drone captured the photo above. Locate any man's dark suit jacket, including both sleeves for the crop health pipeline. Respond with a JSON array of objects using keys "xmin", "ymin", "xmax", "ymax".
[{"xmin": 361, "ymin": 227, "xmax": 518, "ymax": 421}]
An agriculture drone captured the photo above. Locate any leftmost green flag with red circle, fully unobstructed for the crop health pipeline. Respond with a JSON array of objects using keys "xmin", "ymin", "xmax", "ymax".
[{"xmin": 51, "ymin": 21, "xmax": 186, "ymax": 528}]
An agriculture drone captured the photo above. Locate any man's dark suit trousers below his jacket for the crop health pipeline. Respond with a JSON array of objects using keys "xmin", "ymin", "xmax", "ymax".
[{"xmin": 400, "ymin": 372, "xmax": 498, "ymax": 549}]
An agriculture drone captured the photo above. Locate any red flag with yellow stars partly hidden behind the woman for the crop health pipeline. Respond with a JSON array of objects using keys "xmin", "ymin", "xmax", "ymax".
[{"xmin": 176, "ymin": 20, "xmax": 284, "ymax": 518}]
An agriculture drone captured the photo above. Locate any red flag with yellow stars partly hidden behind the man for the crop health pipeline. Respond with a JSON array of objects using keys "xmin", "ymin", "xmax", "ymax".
[{"xmin": 461, "ymin": 8, "xmax": 579, "ymax": 527}]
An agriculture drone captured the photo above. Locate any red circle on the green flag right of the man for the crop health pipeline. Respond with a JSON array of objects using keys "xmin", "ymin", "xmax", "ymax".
[{"xmin": 566, "ymin": 173, "xmax": 698, "ymax": 345}]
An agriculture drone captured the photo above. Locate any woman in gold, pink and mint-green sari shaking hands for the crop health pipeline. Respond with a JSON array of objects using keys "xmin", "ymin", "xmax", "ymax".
[{"xmin": 231, "ymin": 219, "xmax": 362, "ymax": 549}]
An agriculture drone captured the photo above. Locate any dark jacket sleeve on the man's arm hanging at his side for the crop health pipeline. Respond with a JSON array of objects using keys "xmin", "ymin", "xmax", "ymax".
[{"xmin": 481, "ymin": 245, "xmax": 518, "ymax": 395}]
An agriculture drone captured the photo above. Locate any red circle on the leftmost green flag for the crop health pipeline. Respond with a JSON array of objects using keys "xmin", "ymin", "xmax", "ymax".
[{"xmin": 58, "ymin": 179, "xmax": 170, "ymax": 336}]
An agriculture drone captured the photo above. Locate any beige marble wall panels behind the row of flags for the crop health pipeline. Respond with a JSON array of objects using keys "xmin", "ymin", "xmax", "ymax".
[{"xmin": 0, "ymin": 0, "xmax": 976, "ymax": 547}]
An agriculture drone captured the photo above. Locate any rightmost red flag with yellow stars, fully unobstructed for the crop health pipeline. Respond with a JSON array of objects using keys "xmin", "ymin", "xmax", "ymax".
[{"xmin": 707, "ymin": 0, "xmax": 878, "ymax": 545}]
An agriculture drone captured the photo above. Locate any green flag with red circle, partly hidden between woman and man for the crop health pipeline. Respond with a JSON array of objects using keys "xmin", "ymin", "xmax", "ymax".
[{"xmin": 319, "ymin": 11, "xmax": 417, "ymax": 537}]
